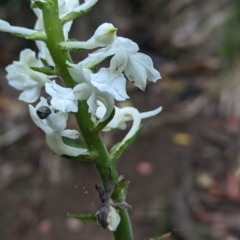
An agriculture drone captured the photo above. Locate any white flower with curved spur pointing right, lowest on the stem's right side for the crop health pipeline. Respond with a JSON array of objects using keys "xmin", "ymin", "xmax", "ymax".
[{"xmin": 96, "ymin": 102, "xmax": 162, "ymax": 141}]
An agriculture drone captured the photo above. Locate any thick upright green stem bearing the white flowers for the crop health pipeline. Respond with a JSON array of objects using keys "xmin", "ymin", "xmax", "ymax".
[{"xmin": 43, "ymin": 0, "xmax": 133, "ymax": 240}]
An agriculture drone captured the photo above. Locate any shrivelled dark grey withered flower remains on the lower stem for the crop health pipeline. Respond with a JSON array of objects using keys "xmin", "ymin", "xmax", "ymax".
[{"xmin": 95, "ymin": 168, "xmax": 132, "ymax": 229}]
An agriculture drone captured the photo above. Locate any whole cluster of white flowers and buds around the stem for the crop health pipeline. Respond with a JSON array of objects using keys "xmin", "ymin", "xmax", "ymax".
[{"xmin": 0, "ymin": 0, "xmax": 161, "ymax": 232}]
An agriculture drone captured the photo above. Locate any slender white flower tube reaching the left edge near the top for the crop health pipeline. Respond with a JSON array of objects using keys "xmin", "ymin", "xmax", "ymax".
[{"xmin": 0, "ymin": 19, "xmax": 38, "ymax": 36}]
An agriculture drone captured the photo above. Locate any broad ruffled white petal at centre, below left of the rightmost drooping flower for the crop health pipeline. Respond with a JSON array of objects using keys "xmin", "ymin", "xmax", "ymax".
[{"xmin": 91, "ymin": 68, "xmax": 129, "ymax": 101}]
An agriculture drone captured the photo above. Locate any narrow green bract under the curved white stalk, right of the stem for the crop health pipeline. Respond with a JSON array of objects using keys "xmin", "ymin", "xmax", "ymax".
[{"xmin": 110, "ymin": 127, "xmax": 142, "ymax": 162}]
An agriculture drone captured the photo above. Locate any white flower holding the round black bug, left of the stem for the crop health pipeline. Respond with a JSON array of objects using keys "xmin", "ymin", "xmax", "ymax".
[{"xmin": 29, "ymin": 97, "xmax": 87, "ymax": 156}]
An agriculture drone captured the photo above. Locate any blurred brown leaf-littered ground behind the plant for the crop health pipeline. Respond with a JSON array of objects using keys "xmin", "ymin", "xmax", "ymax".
[{"xmin": 0, "ymin": 0, "xmax": 240, "ymax": 240}]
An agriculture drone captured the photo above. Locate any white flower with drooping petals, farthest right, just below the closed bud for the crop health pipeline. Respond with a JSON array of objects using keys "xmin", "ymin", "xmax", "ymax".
[{"xmin": 79, "ymin": 37, "xmax": 161, "ymax": 90}]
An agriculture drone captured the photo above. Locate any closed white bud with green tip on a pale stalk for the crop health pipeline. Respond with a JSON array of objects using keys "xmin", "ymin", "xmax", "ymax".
[{"xmin": 59, "ymin": 23, "xmax": 117, "ymax": 50}]
